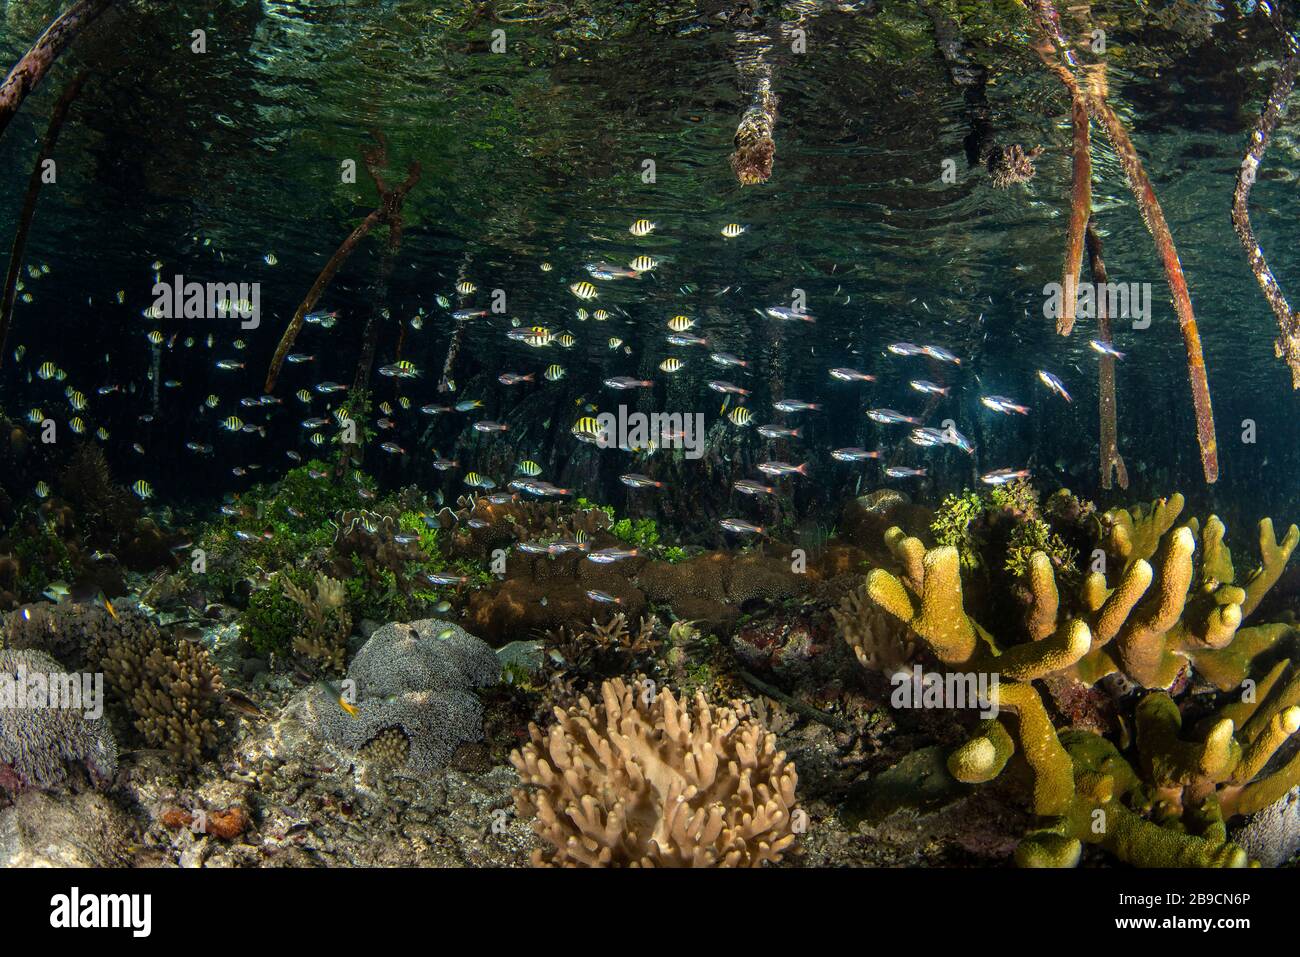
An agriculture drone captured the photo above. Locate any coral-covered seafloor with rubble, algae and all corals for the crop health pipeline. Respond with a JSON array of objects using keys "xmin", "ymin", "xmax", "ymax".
[{"xmin": 0, "ymin": 442, "xmax": 1300, "ymax": 867}]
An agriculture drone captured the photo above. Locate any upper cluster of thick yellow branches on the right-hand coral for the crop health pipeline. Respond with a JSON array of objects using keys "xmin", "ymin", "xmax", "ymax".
[{"xmin": 866, "ymin": 495, "xmax": 1300, "ymax": 690}]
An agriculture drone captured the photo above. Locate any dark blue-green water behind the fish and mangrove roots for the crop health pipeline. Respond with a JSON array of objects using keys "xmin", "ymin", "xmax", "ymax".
[{"xmin": 0, "ymin": 0, "xmax": 1300, "ymax": 533}]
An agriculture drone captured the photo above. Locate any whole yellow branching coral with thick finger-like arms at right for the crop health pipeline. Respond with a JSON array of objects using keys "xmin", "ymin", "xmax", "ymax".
[{"xmin": 850, "ymin": 495, "xmax": 1300, "ymax": 866}]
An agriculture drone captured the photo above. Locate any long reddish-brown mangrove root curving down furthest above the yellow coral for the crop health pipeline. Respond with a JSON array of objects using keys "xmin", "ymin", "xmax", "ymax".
[{"xmin": 1028, "ymin": 0, "xmax": 1218, "ymax": 482}]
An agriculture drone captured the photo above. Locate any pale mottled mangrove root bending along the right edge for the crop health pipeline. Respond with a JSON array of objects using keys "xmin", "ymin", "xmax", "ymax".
[{"xmin": 1232, "ymin": 35, "xmax": 1300, "ymax": 389}]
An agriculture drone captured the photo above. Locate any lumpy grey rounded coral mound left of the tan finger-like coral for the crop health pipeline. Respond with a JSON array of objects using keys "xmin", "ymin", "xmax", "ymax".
[{"xmin": 307, "ymin": 619, "xmax": 501, "ymax": 775}]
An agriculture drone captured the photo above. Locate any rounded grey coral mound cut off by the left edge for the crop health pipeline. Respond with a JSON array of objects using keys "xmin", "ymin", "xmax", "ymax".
[{"xmin": 0, "ymin": 650, "xmax": 117, "ymax": 792}]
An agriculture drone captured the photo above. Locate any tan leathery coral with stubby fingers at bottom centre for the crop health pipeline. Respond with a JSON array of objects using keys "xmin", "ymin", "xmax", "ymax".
[{"xmin": 510, "ymin": 679, "xmax": 798, "ymax": 867}]
